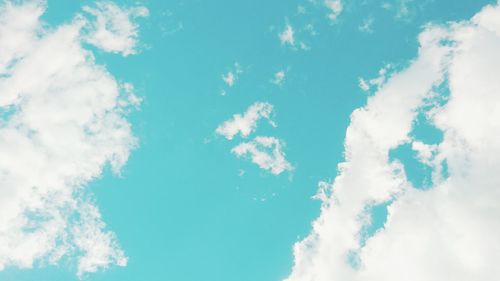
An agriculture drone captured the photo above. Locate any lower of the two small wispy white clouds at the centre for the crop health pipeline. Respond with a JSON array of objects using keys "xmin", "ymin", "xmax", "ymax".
[{"xmin": 231, "ymin": 136, "xmax": 293, "ymax": 175}]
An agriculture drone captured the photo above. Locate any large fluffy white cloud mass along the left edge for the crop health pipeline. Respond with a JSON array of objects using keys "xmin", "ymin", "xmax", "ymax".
[{"xmin": 0, "ymin": 1, "xmax": 146, "ymax": 276}]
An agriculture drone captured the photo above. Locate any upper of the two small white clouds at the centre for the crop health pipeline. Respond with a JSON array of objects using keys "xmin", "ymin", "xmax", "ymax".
[{"xmin": 215, "ymin": 102, "xmax": 276, "ymax": 140}]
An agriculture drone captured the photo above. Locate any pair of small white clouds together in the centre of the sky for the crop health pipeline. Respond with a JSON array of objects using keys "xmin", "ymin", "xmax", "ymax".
[{"xmin": 215, "ymin": 102, "xmax": 293, "ymax": 175}]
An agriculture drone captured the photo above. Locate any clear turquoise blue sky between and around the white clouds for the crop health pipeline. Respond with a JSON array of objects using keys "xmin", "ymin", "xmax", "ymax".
[{"xmin": 0, "ymin": 0, "xmax": 494, "ymax": 281}]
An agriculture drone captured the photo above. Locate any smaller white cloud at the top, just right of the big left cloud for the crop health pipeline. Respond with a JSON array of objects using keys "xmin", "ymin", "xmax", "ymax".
[{"xmin": 83, "ymin": 1, "xmax": 149, "ymax": 56}]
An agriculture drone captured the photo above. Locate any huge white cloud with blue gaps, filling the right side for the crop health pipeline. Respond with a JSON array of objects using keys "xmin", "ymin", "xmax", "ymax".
[{"xmin": 286, "ymin": 2, "xmax": 500, "ymax": 281}]
